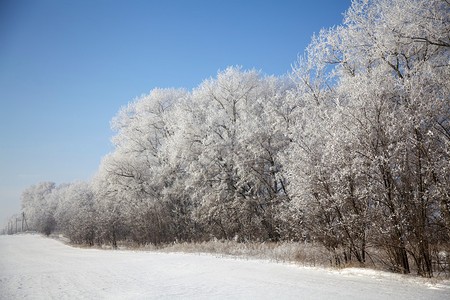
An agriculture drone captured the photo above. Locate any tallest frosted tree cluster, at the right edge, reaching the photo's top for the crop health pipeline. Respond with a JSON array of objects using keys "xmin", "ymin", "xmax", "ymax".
[{"xmin": 290, "ymin": 0, "xmax": 450, "ymax": 276}]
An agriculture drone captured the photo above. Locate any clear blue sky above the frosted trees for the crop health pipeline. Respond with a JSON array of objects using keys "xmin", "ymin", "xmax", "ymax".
[{"xmin": 0, "ymin": 0, "xmax": 351, "ymax": 226}]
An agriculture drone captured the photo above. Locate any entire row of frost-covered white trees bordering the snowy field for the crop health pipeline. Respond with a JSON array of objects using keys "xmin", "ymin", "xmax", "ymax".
[{"xmin": 5, "ymin": 0, "xmax": 450, "ymax": 277}]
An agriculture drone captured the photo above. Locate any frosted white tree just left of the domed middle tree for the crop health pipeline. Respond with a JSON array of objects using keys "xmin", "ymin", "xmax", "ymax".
[{"xmin": 95, "ymin": 89, "xmax": 192, "ymax": 243}]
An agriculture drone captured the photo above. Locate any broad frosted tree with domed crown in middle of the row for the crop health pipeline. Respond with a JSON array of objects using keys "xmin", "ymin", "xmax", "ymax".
[{"xmin": 171, "ymin": 67, "xmax": 289, "ymax": 240}]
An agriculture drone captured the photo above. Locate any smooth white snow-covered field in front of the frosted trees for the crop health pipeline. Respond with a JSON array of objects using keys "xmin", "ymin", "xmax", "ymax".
[{"xmin": 0, "ymin": 235, "xmax": 450, "ymax": 299}]
